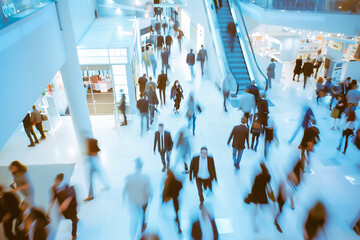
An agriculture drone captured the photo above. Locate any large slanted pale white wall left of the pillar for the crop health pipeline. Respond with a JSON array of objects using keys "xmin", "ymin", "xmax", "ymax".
[{"xmin": 0, "ymin": 4, "xmax": 65, "ymax": 149}]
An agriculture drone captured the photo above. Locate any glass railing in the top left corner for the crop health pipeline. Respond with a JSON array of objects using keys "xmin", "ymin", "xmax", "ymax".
[{"xmin": 0, "ymin": 0, "xmax": 54, "ymax": 29}]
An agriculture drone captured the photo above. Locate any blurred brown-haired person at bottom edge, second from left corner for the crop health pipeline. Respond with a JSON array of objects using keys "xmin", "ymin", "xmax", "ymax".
[{"xmin": 24, "ymin": 207, "xmax": 50, "ymax": 240}]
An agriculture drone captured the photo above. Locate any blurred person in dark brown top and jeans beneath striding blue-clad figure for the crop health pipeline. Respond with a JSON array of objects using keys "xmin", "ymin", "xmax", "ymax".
[{"xmin": 299, "ymin": 126, "xmax": 320, "ymax": 172}]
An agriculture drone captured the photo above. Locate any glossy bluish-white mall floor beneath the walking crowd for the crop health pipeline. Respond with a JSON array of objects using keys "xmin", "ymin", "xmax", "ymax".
[{"xmin": 0, "ymin": 37, "xmax": 360, "ymax": 240}]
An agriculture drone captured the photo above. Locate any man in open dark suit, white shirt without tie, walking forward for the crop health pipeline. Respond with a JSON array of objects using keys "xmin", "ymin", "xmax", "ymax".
[{"xmin": 189, "ymin": 147, "xmax": 217, "ymax": 208}]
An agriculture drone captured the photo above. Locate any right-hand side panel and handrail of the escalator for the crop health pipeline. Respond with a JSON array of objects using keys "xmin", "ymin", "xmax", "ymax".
[{"xmin": 228, "ymin": 0, "xmax": 267, "ymax": 88}]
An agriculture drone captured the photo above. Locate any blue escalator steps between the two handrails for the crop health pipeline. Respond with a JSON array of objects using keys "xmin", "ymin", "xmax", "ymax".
[{"xmin": 217, "ymin": 0, "xmax": 250, "ymax": 93}]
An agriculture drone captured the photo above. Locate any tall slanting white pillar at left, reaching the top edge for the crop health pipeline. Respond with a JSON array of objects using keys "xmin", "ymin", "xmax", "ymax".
[{"xmin": 57, "ymin": 0, "xmax": 93, "ymax": 153}]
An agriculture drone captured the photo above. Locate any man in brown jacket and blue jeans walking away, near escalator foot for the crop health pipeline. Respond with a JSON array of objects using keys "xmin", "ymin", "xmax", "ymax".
[{"xmin": 228, "ymin": 117, "xmax": 249, "ymax": 169}]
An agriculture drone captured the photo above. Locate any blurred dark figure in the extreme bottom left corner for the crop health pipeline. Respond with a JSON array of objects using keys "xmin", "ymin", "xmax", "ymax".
[{"xmin": 0, "ymin": 185, "xmax": 21, "ymax": 240}]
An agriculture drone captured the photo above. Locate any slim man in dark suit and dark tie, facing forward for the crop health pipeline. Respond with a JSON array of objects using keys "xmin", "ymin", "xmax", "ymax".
[{"xmin": 154, "ymin": 123, "xmax": 173, "ymax": 172}]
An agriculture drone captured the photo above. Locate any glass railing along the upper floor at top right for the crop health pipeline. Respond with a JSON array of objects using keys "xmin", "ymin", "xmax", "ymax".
[{"xmin": 237, "ymin": 0, "xmax": 360, "ymax": 14}]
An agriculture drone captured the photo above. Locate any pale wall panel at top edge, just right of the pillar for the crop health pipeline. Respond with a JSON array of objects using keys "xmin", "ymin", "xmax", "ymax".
[{"xmin": 69, "ymin": 0, "xmax": 95, "ymax": 43}]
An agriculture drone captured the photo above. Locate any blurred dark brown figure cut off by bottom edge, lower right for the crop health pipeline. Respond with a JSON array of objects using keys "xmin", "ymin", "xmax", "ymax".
[{"xmin": 304, "ymin": 201, "xmax": 327, "ymax": 240}]
